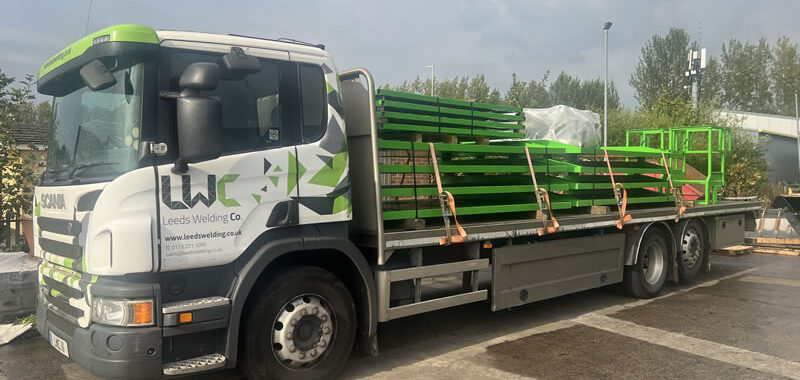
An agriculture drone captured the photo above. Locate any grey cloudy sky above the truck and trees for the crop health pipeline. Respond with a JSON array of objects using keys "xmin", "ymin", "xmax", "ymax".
[{"xmin": 0, "ymin": 0, "xmax": 800, "ymax": 108}]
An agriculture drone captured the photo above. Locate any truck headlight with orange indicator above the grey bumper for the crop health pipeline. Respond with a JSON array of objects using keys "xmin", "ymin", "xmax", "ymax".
[{"xmin": 92, "ymin": 297, "xmax": 155, "ymax": 327}]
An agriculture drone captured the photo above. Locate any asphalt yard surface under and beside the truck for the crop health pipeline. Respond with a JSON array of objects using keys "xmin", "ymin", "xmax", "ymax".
[{"xmin": 0, "ymin": 254, "xmax": 800, "ymax": 380}]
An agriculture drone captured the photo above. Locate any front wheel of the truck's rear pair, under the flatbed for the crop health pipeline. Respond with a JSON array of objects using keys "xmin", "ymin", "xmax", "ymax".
[{"xmin": 624, "ymin": 229, "xmax": 669, "ymax": 298}]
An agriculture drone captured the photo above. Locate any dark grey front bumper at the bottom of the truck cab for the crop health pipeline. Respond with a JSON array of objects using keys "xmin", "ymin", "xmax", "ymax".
[{"xmin": 36, "ymin": 297, "xmax": 163, "ymax": 379}]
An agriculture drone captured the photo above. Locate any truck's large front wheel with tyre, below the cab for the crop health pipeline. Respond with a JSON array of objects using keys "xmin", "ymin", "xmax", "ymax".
[{"xmin": 242, "ymin": 267, "xmax": 356, "ymax": 380}]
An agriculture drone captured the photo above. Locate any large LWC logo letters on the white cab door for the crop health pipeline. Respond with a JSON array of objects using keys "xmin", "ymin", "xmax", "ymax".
[{"xmin": 161, "ymin": 174, "xmax": 239, "ymax": 210}]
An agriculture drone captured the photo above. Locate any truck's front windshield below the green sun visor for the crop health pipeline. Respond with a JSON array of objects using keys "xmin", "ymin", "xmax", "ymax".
[{"xmin": 42, "ymin": 63, "xmax": 143, "ymax": 185}]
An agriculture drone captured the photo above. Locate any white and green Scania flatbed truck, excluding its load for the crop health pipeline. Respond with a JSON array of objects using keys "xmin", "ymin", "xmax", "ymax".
[{"xmin": 29, "ymin": 25, "xmax": 760, "ymax": 379}]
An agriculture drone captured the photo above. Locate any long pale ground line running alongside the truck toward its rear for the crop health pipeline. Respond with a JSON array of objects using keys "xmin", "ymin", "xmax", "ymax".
[{"xmin": 352, "ymin": 268, "xmax": 764, "ymax": 379}]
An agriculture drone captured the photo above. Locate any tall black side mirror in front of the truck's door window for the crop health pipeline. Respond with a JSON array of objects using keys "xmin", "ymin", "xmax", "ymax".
[{"xmin": 173, "ymin": 62, "xmax": 222, "ymax": 172}]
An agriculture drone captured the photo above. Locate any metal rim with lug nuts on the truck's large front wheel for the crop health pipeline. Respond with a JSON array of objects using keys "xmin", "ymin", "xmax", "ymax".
[{"xmin": 272, "ymin": 294, "xmax": 336, "ymax": 369}]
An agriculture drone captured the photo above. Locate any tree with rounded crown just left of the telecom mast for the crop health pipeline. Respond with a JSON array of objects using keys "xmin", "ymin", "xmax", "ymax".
[{"xmin": 630, "ymin": 28, "xmax": 689, "ymax": 109}]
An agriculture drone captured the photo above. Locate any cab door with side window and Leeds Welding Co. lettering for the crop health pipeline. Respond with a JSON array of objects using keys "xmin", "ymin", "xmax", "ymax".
[{"xmin": 158, "ymin": 50, "xmax": 305, "ymax": 270}]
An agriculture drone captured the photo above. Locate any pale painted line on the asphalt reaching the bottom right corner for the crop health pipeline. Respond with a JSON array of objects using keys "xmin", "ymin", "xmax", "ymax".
[{"xmin": 573, "ymin": 313, "xmax": 800, "ymax": 379}]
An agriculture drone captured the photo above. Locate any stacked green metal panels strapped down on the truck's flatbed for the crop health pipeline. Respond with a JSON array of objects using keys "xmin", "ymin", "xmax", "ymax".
[{"xmin": 376, "ymin": 90, "xmax": 696, "ymax": 221}]
